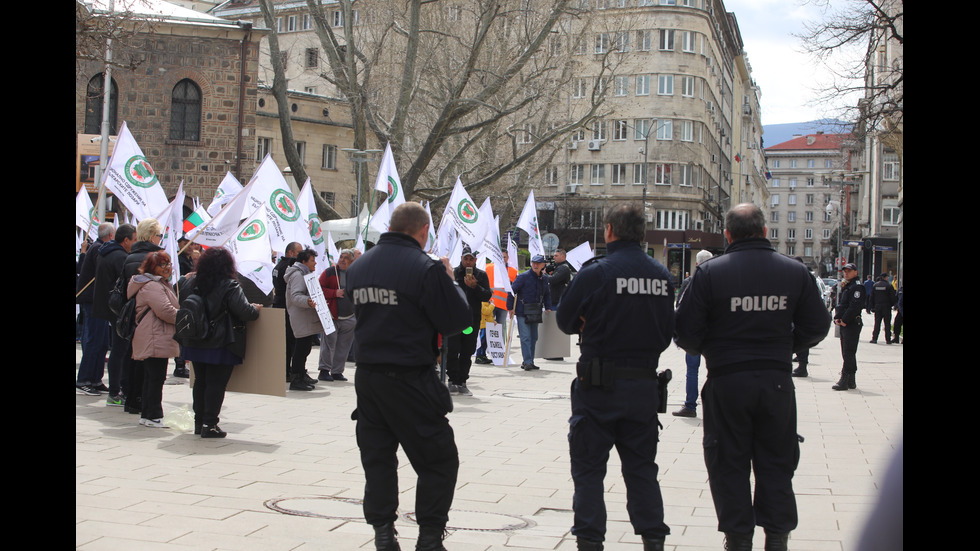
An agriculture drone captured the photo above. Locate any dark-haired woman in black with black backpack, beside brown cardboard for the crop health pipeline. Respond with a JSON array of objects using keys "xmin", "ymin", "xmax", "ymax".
[{"xmin": 181, "ymin": 247, "xmax": 262, "ymax": 438}]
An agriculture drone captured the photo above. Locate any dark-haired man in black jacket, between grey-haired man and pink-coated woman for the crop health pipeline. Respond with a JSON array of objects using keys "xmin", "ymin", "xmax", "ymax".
[{"xmin": 92, "ymin": 224, "xmax": 136, "ymax": 406}]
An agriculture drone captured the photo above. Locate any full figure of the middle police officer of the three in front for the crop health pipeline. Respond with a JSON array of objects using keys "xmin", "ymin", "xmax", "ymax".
[{"xmin": 556, "ymin": 204, "xmax": 674, "ymax": 551}]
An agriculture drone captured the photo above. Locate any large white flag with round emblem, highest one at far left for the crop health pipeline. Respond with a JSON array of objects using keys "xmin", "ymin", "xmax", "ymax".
[{"xmin": 102, "ymin": 121, "xmax": 168, "ymax": 221}]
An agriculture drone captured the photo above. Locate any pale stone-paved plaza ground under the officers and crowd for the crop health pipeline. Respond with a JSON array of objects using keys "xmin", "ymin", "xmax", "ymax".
[{"xmin": 75, "ymin": 324, "xmax": 904, "ymax": 551}]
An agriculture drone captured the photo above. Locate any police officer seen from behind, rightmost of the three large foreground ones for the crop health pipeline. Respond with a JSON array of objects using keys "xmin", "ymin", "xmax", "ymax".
[{"xmin": 676, "ymin": 204, "xmax": 830, "ymax": 551}]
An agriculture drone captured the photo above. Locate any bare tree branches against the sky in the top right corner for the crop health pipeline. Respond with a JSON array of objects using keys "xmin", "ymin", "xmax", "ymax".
[{"xmin": 798, "ymin": 0, "xmax": 905, "ymax": 142}]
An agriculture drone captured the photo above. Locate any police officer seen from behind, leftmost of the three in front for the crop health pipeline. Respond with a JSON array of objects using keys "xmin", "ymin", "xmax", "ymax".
[{"xmin": 345, "ymin": 203, "xmax": 472, "ymax": 551}]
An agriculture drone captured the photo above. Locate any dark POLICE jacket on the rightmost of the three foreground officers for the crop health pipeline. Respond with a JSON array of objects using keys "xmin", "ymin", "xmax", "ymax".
[{"xmin": 675, "ymin": 238, "xmax": 830, "ymax": 377}]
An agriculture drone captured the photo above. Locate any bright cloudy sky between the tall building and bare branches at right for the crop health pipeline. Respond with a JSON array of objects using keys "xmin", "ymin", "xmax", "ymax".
[{"xmin": 724, "ymin": 0, "xmax": 856, "ymax": 124}]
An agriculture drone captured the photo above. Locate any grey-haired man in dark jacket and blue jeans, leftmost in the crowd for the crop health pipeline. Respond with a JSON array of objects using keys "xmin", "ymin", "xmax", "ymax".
[{"xmin": 75, "ymin": 222, "xmax": 116, "ymax": 396}]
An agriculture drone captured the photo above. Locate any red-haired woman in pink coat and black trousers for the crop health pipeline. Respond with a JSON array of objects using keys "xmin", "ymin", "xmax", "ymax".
[{"xmin": 127, "ymin": 251, "xmax": 180, "ymax": 428}]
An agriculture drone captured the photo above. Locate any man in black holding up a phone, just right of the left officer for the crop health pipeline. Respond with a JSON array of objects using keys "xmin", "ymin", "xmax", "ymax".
[{"xmin": 446, "ymin": 246, "xmax": 493, "ymax": 396}]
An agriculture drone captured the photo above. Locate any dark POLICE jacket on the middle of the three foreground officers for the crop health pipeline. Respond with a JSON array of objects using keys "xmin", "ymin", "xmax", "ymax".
[{"xmin": 556, "ymin": 240, "xmax": 674, "ymax": 366}]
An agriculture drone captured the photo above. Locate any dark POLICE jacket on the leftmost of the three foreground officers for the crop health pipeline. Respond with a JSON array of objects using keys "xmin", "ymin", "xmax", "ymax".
[{"xmin": 344, "ymin": 232, "xmax": 473, "ymax": 367}]
